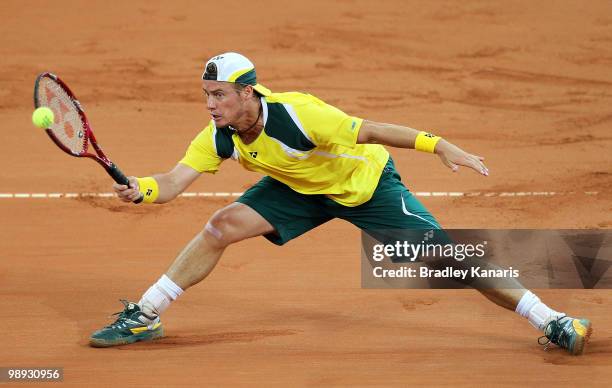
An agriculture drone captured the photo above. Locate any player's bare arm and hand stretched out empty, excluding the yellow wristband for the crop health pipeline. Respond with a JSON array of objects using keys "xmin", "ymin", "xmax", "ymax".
[{"xmin": 357, "ymin": 120, "xmax": 489, "ymax": 175}]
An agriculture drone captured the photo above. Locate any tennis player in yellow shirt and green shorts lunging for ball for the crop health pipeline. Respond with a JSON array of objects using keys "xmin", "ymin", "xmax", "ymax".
[{"xmin": 90, "ymin": 52, "xmax": 591, "ymax": 354}]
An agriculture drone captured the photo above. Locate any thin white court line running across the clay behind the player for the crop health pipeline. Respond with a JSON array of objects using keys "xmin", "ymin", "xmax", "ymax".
[{"xmin": 0, "ymin": 191, "xmax": 599, "ymax": 199}]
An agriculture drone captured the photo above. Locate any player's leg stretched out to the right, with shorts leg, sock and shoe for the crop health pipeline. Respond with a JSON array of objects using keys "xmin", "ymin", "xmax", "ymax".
[{"xmin": 329, "ymin": 159, "xmax": 591, "ymax": 354}]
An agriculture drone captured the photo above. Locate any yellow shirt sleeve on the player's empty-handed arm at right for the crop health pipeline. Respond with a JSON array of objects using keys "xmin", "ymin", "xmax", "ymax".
[{"xmin": 298, "ymin": 97, "xmax": 363, "ymax": 148}]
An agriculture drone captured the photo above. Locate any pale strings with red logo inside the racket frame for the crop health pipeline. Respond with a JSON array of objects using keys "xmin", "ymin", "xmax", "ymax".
[{"xmin": 37, "ymin": 77, "xmax": 87, "ymax": 154}]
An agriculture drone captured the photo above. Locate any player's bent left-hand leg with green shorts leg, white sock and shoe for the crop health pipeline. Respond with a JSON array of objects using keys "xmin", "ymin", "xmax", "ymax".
[{"xmin": 90, "ymin": 177, "xmax": 331, "ymax": 347}]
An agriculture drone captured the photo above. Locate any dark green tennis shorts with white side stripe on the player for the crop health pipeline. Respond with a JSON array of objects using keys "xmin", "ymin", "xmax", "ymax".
[{"xmin": 236, "ymin": 157, "xmax": 440, "ymax": 245}]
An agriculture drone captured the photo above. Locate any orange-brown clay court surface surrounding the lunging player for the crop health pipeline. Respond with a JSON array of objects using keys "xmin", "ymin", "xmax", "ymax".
[{"xmin": 0, "ymin": 0, "xmax": 612, "ymax": 387}]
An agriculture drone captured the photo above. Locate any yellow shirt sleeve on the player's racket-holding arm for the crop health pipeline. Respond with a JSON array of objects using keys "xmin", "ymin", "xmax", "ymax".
[{"xmin": 179, "ymin": 123, "xmax": 223, "ymax": 174}]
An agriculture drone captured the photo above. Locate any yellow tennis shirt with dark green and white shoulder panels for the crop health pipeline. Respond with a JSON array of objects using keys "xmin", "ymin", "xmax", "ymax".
[{"xmin": 180, "ymin": 92, "xmax": 389, "ymax": 206}]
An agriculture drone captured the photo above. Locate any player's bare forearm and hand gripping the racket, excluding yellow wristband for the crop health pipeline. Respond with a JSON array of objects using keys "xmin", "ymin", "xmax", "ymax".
[{"xmin": 113, "ymin": 163, "xmax": 200, "ymax": 203}]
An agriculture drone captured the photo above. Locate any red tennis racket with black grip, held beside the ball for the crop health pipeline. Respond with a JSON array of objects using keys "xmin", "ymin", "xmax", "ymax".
[{"xmin": 34, "ymin": 72, "xmax": 143, "ymax": 203}]
